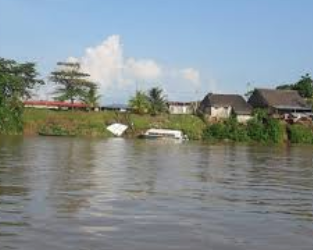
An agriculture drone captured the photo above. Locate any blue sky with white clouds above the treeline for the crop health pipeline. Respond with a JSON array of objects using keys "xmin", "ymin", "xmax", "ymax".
[{"xmin": 0, "ymin": 0, "xmax": 313, "ymax": 104}]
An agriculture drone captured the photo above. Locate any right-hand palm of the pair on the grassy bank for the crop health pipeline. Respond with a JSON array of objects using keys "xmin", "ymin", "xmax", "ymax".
[{"xmin": 148, "ymin": 87, "xmax": 167, "ymax": 115}]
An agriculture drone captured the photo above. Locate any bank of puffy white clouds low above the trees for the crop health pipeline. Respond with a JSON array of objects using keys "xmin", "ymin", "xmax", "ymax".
[{"xmin": 68, "ymin": 35, "xmax": 205, "ymax": 101}]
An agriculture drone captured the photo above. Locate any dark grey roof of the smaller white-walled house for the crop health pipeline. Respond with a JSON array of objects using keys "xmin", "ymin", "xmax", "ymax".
[{"xmin": 200, "ymin": 93, "xmax": 252, "ymax": 115}]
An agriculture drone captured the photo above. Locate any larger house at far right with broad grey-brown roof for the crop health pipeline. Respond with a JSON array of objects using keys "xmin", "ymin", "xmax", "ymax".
[{"xmin": 248, "ymin": 89, "xmax": 312, "ymax": 115}]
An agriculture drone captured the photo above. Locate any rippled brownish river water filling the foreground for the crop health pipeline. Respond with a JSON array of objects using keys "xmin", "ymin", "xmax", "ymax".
[{"xmin": 0, "ymin": 137, "xmax": 313, "ymax": 250}]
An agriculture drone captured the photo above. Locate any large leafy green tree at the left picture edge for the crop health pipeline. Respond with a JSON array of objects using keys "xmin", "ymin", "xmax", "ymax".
[{"xmin": 0, "ymin": 58, "xmax": 44, "ymax": 133}]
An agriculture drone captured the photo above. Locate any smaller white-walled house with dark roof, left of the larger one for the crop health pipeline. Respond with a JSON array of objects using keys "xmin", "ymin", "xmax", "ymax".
[{"xmin": 199, "ymin": 93, "xmax": 252, "ymax": 123}]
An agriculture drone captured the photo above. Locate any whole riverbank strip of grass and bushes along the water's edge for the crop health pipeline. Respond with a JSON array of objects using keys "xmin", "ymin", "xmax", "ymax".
[{"xmin": 18, "ymin": 109, "xmax": 313, "ymax": 144}]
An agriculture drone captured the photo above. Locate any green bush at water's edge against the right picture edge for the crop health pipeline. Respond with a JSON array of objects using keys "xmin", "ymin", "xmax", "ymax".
[{"xmin": 288, "ymin": 124, "xmax": 313, "ymax": 143}]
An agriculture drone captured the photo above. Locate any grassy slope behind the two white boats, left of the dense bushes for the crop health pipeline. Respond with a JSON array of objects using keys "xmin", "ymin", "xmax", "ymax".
[{"xmin": 23, "ymin": 109, "xmax": 205, "ymax": 139}]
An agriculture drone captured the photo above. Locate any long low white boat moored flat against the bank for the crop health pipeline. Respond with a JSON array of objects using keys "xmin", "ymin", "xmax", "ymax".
[{"xmin": 140, "ymin": 128, "xmax": 188, "ymax": 140}]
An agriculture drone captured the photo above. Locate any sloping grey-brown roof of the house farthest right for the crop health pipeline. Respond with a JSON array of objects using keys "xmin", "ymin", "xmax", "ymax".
[{"xmin": 251, "ymin": 89, "xmax": 311, "ymax": 109}]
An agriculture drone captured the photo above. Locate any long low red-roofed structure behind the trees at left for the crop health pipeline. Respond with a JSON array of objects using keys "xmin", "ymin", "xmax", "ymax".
[{"xmin": 23, "ymin": 101, "xmax": 89, "ymax": 109}]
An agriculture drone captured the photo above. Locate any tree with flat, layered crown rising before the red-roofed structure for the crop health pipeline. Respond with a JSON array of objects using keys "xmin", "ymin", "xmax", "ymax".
[{"xmin": 49, "ymin": 62, "xmax": 96, "ymax": 103}]
